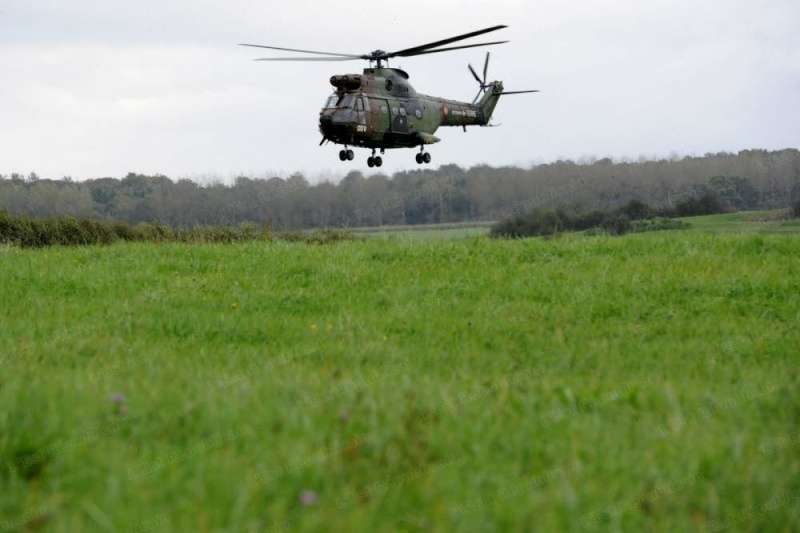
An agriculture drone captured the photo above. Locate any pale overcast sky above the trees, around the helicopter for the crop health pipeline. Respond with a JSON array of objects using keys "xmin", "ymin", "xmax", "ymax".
[{"xmin": 0, "ymin": 0, "xmax": 800, "ymax": 182}]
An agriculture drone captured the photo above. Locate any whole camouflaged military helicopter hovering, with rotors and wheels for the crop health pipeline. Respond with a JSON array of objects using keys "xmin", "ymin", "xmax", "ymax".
[{"xmin": 241, "ymin": 25, "xmax": 539, "ymax": 167}]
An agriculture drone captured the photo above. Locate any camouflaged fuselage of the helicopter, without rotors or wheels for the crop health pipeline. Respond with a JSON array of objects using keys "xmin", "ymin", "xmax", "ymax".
[{"xmin": 319, "ymin": 68, "xmax": 503, "ymax": 149}]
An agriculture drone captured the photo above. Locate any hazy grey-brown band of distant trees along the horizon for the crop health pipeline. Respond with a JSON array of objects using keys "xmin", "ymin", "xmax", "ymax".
[{"xmin": 0, "ymin": 149, "xmax": 800, "ymax": 230}]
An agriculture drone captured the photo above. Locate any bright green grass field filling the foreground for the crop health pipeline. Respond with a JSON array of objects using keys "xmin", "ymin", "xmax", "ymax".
[{"xmin": 0, "ymin": 214, "xmax": 800, "ymax": 533}]
